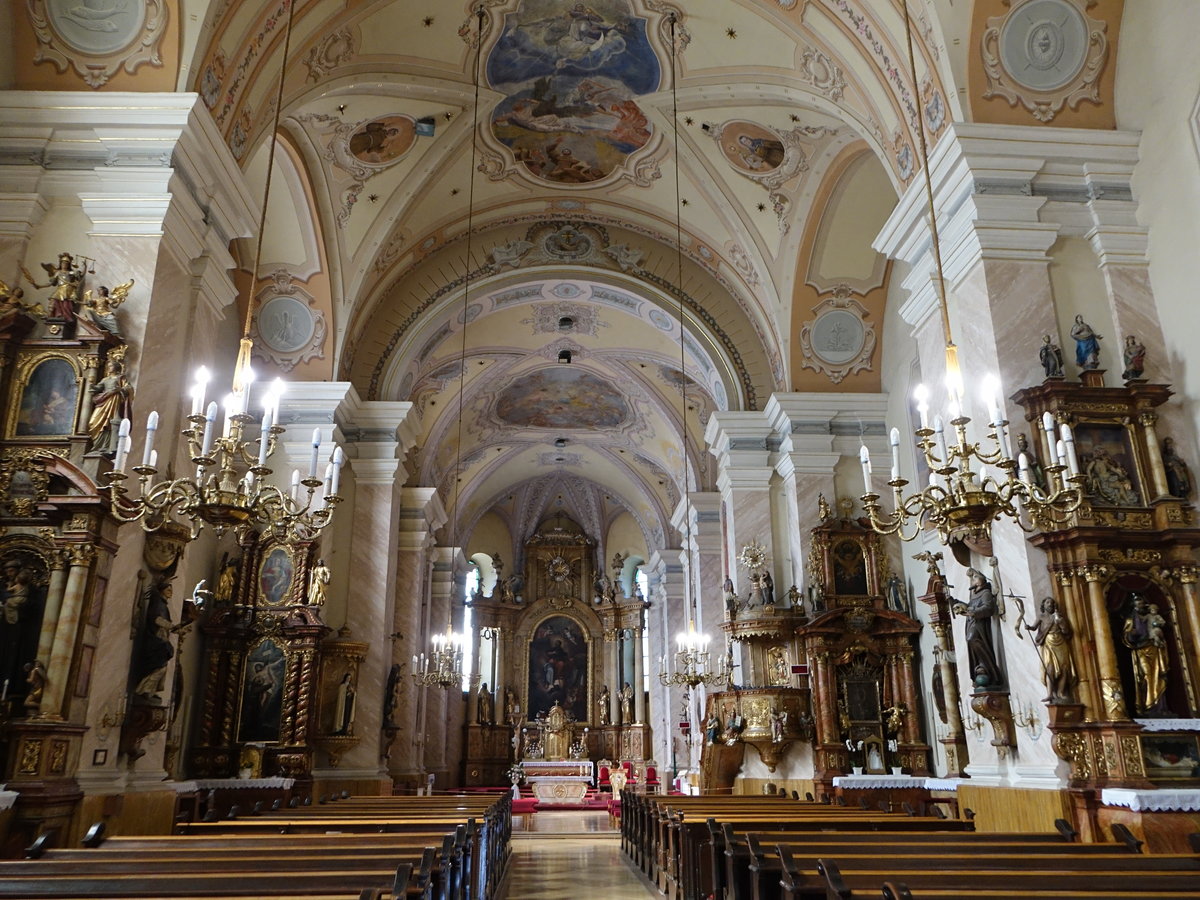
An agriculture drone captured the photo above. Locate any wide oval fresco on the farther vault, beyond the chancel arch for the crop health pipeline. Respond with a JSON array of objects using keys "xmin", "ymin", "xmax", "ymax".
[{"xmin": 496, "ymin": 366, "xmax": 630, "ymax": 428}]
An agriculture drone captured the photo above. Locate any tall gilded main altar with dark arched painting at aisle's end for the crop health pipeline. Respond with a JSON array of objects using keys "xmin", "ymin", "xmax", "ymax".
[{"xmin": 464, "ymin": 517, "xmax": 652, "ymax": 787}]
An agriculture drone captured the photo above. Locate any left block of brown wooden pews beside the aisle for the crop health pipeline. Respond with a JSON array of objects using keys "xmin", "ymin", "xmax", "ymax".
[{"xmin": 14, "ymin": 796, "xmax": 511, "ymax": 900}]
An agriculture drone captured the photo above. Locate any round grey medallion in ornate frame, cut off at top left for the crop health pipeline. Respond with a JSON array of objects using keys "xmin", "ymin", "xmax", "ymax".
[{"xmin": 28, "ymin": 0, "xmax": 167, "ymax": 88}]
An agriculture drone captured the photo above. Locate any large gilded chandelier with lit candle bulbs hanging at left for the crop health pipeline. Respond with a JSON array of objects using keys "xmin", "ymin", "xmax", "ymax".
[{"xmin": 101, "ymin": 366, "xmax": 346, "ymax": 541}]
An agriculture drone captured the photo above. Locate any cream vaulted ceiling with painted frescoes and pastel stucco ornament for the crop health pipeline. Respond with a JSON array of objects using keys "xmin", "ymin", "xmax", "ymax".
[{"xmin": 180, "ymin": 0, "xmax": 955, "ymax": 556}]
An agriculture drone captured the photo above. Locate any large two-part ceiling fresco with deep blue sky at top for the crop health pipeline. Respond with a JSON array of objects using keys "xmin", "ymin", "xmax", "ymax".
[{"xmin": 487, "ymin": 0, "xmax": 661, "ymax": 185}]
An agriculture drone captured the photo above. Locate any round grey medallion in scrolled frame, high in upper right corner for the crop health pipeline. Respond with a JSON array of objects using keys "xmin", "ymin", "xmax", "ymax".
[{"xmin": 979, "ymin": 0, "xmax": 1109, "ymax": 122}]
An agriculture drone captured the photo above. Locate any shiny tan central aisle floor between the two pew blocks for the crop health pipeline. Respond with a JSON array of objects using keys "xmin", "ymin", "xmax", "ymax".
[{"xmin": 508, "ymin": 811, "xmax": 661, "ymax": 900}]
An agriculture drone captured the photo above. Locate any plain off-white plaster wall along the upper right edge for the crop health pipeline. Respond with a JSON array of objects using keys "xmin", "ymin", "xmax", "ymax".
[{"xmin": 1116, "ymin": 0, "xmax": 1200, "ymax": 436}]
